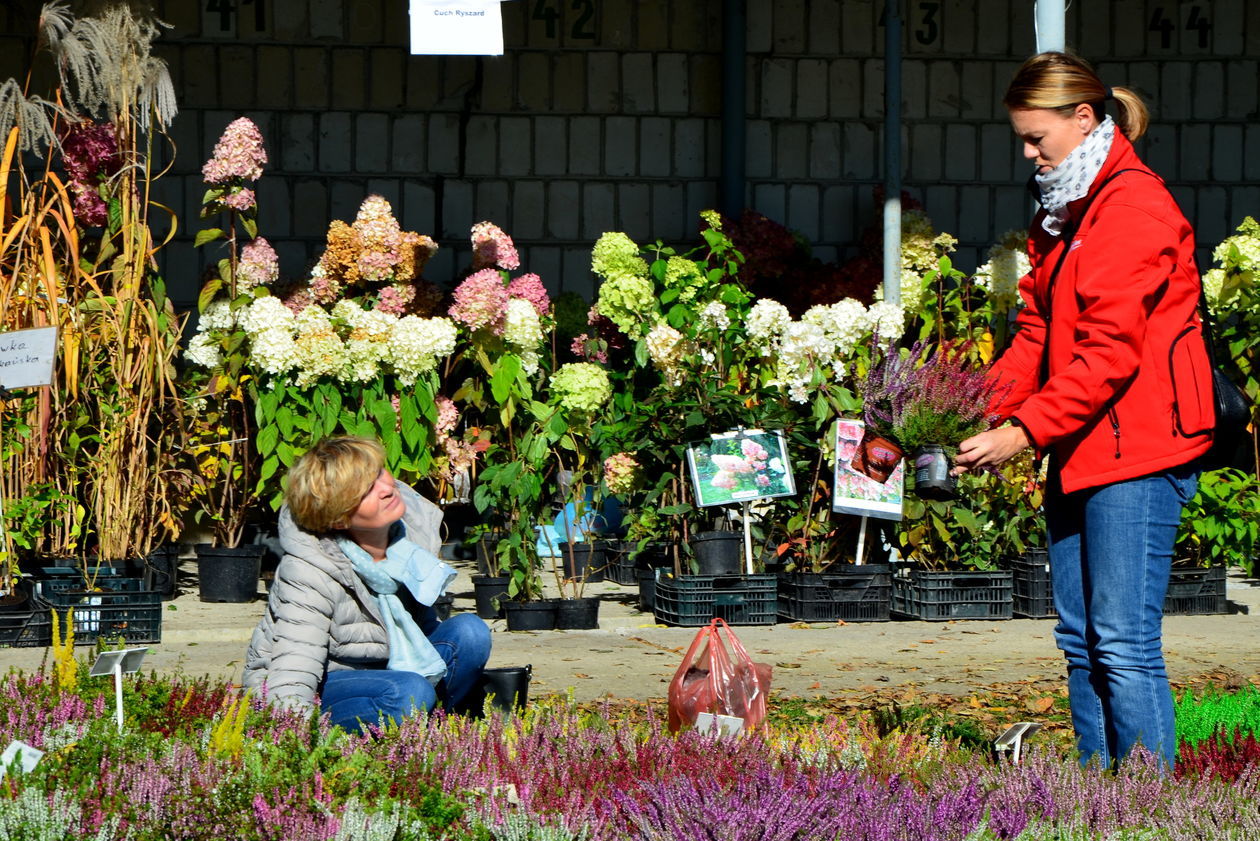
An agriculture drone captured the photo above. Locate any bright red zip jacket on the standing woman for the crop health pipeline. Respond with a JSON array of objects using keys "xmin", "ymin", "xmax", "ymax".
[{"xmin": 992, "ymin": 132, "xmax": 1215, "ymax": 493}]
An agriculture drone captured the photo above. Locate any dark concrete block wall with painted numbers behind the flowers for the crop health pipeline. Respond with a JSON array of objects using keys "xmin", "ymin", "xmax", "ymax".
[{"xmin": 0, "ymin": 0, "xmax": 1260, "ymax": 304}]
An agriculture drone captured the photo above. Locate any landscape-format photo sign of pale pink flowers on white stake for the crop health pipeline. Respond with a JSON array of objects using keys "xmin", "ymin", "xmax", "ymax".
[{"xmin": 687, "ymin": 429, "xmax": 796, "ymax": 508}]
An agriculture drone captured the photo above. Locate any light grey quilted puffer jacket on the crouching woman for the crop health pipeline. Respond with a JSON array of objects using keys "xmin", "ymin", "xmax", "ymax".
[{"xmin": 243, "ymin": 483, "xmax": 442, "ymax": 709}]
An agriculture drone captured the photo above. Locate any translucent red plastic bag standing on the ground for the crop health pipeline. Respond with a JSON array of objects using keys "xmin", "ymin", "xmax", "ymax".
[{"xmin": 669, "ymin": 619, "xmax": 771, "ymax": 731}]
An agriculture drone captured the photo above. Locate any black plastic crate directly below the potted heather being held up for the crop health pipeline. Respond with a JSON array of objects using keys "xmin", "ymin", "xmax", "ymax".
[{"xmin": 892, "ymin": 567, "xmax": 1012, "ymax": 622}]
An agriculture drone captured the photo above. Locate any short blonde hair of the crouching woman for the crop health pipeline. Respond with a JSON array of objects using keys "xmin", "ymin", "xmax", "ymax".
[{"xmin": 285, "ymin": 436, "xmax": 386, "ymax": 535}]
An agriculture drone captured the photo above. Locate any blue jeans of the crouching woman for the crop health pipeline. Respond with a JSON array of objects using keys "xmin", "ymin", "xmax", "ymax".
[{"xmin": 320, "ymin": 613, "xmax": 490, "ymax": 733}]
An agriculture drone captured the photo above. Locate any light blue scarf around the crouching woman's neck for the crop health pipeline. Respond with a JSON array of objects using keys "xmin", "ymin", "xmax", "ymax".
[{"xmin": 338, "ymin": 527, "xmax": 455, "ymax": 686}]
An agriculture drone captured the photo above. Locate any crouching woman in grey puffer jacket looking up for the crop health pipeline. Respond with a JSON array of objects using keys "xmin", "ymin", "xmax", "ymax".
[{"xmin": 244, "ymin": 438, "xmax": 490, "ymax": 731}]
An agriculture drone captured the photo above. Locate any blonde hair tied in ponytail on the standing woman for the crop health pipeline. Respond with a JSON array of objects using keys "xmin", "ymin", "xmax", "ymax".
[{"xmin": 1002, "ymin": 53, "xmax": 1150, "ymax": 140}]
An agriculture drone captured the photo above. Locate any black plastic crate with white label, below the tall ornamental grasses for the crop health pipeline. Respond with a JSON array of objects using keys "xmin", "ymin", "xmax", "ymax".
[{"xmin": 43, "ymin": 579, "xmax": 161, "ymax": 644}]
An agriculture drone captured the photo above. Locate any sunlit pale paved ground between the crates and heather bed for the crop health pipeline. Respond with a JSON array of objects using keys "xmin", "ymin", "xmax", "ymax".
[{"xmin": 0, "ymin": 561, "xmax": 1260, "ymax": 701}]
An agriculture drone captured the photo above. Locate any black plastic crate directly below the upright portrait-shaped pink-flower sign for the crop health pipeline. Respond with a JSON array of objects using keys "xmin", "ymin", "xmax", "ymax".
[{"xmin": 779, "ymin": 564, "xmax": 892, "ymax": 622}]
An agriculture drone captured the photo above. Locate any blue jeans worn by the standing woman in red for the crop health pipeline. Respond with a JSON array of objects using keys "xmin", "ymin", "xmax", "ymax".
[{"xmin": 1046, "ymin": 464, "xmax": 1198, "ymax": 768}]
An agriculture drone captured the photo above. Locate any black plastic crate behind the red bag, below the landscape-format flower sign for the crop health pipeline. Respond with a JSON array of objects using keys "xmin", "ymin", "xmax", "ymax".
[{"xmin": 653, "ymin": 571, "xmax": 779, "ymax": 628}]
